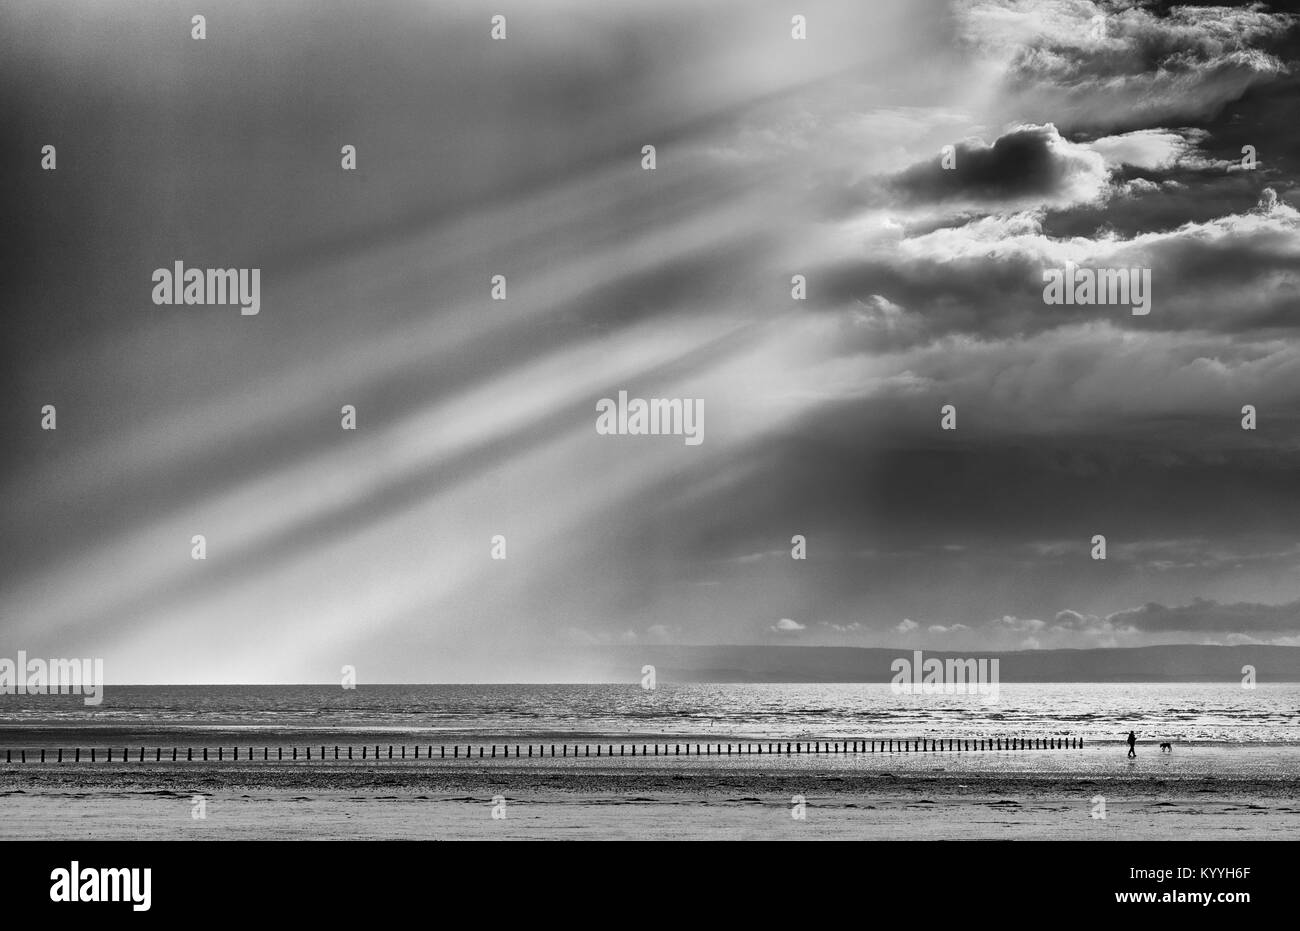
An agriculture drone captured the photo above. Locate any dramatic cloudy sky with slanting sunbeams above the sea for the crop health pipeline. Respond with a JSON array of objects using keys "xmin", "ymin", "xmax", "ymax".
[{"xmin": 0, "ymin": 0, "xmax": 1300, "ymax": 683}]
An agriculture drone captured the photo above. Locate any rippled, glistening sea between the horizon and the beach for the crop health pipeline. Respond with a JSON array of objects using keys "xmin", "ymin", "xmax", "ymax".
[{"xmin": 0, "ymin": 683, "xmax": 1300, "ymax": 746}]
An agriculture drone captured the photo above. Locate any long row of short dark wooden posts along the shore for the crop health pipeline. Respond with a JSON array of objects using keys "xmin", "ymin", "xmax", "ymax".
[{"xmin": 5, "ymin": 737, "xmax": 1083, "ymax": 763}]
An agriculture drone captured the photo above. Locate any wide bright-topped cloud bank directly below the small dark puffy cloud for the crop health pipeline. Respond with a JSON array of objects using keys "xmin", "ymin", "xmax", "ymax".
[{"xmin": 820, "ymin": 188, "xmax": 1300, "ymax": 353}]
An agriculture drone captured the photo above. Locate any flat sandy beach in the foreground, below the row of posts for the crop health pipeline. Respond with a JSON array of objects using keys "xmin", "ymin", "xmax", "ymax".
[{"xmin": 0, "ymin": 742, "xmax": 1300, "ymax": 840}]
